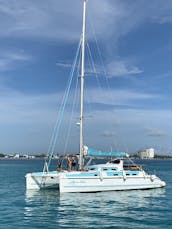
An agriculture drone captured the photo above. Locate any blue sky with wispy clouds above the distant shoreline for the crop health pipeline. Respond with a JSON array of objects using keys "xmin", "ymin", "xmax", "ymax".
[{"xmin": 0, "ymin": 0, "xmax": 172, "ymax": 155}]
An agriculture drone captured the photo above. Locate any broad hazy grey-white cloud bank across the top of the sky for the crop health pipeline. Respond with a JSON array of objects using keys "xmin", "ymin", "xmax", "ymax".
[{"xmin": 0, "ymin": 0, "xmax": 172, "ymax": 42}]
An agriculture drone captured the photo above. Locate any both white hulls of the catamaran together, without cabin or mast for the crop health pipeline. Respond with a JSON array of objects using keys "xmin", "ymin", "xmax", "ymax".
[{"xmin": 26, "ymin": 171, "xmax": 165, "ymax": 192}]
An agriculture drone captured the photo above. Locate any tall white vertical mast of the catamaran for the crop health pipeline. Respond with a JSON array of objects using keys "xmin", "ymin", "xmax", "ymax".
[{"xmin": 79, "ymin": 0, "xmax": 87, "ymax": 170}]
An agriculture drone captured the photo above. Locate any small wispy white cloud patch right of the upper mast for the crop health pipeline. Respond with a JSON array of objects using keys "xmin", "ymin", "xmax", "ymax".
[{"xmin": 107, "ymin": 61, "xmax": 143, "ymax": 77}]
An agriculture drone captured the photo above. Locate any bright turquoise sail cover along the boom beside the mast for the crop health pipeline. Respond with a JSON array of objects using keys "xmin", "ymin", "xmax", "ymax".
[{"xmin": 84, "ymin": 146, "xmax": 129, "ymax": 157}]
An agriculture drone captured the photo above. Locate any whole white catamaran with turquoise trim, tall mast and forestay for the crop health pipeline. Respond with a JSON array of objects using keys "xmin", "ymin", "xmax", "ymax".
[{"xmin": 26, "ymin": 0, "xmax": 166, "ymax": 193}]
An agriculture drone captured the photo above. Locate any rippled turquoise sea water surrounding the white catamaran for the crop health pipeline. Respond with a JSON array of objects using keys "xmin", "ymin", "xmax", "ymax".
[{"xmin": 0, "ymin": 160, "xmax": 172, "ymax": 229}]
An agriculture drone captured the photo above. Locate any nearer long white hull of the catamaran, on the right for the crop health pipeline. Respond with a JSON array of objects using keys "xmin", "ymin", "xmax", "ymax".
[{"xmin": 59, "ymin": 175, "xmax": 165, "ymax": 192}]
